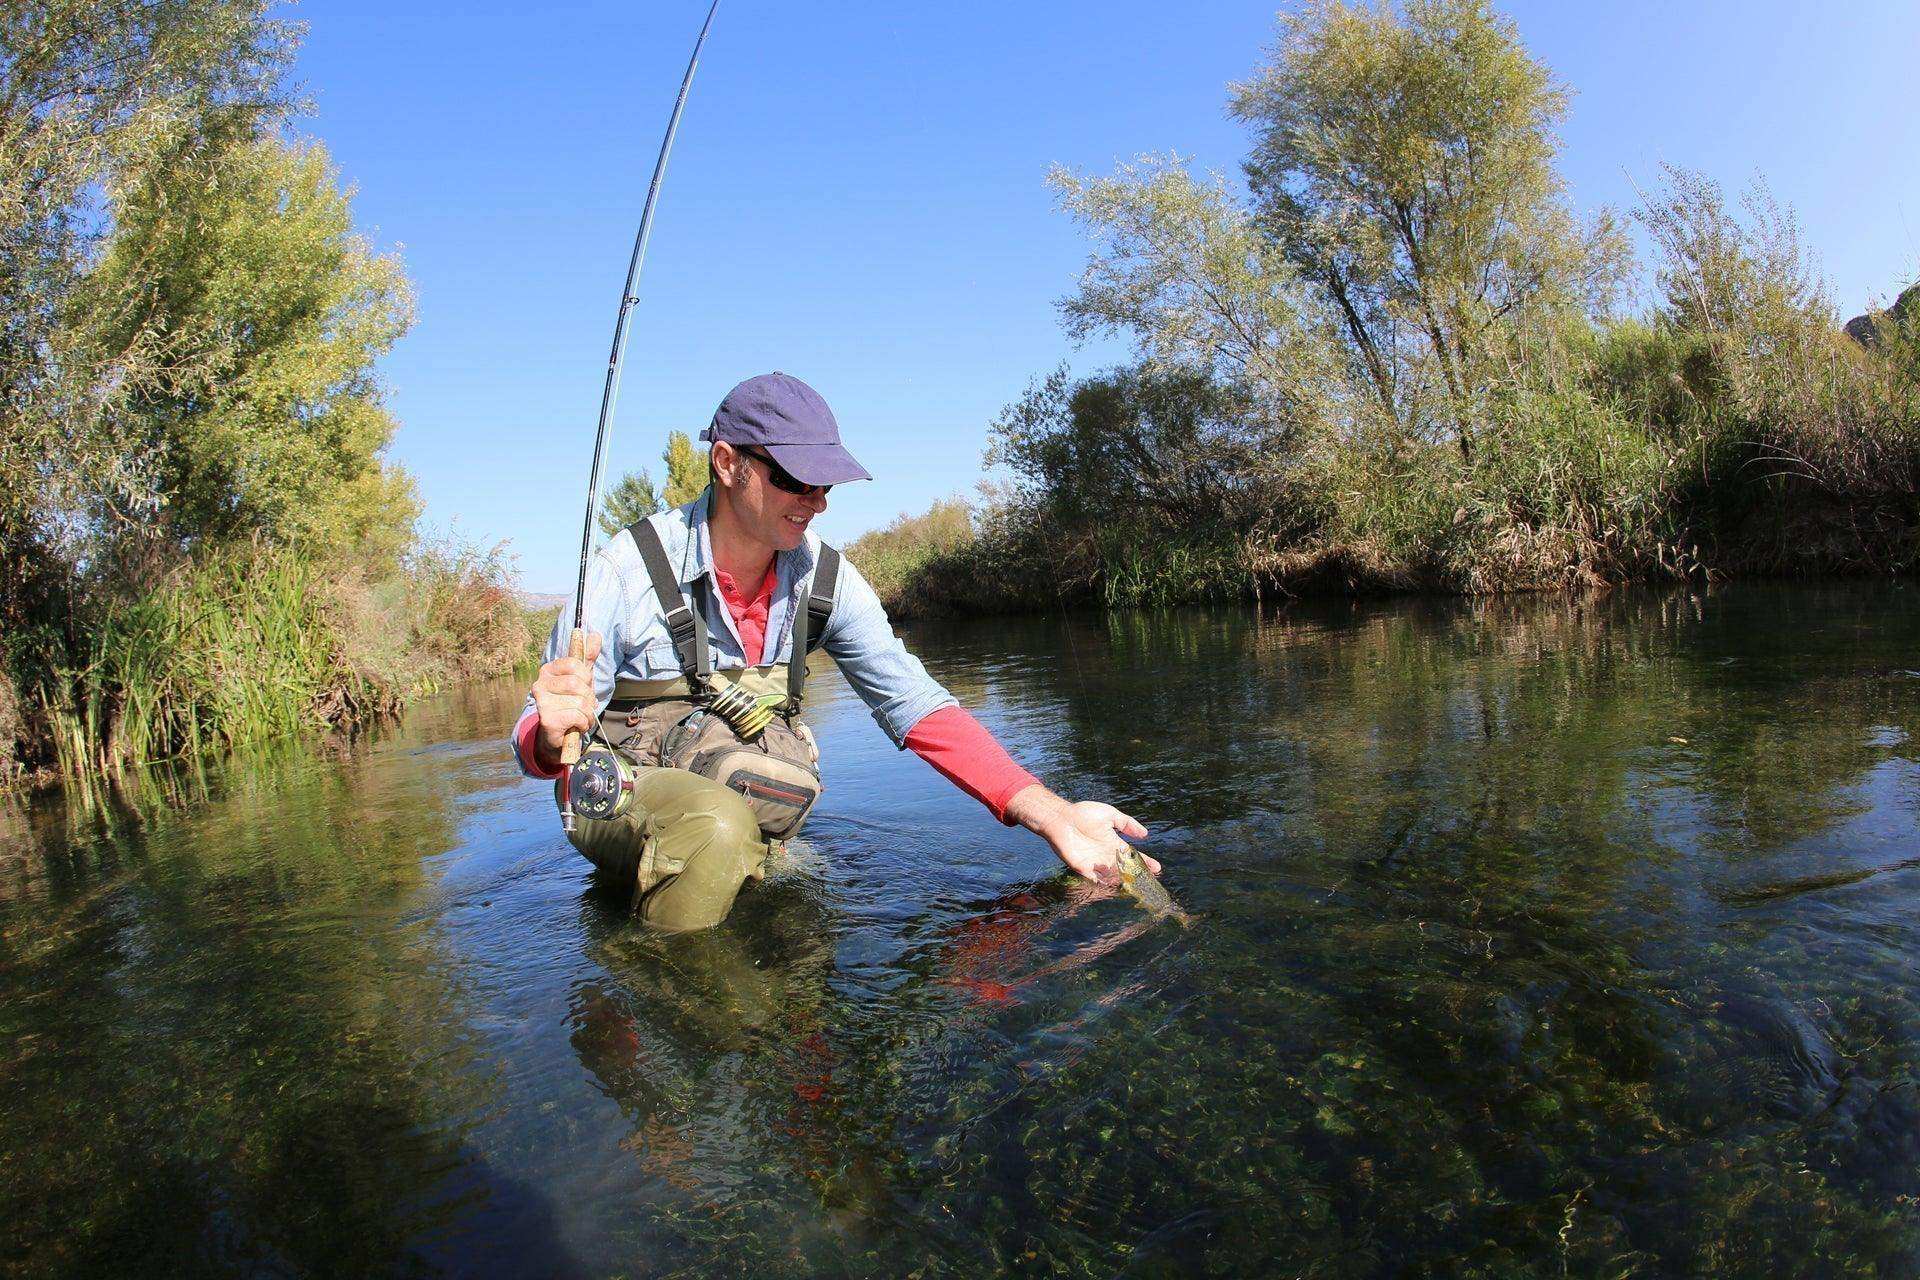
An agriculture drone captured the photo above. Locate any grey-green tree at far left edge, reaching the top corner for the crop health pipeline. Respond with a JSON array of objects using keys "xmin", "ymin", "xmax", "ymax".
[{"xmin": 0, "ymin": 0, "xmax": 298, "ymax": 629}]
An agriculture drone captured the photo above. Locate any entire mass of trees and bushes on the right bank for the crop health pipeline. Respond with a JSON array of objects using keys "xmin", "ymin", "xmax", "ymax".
[{"xmin": 871, "ymin": 0, "xmax": 1920, "ymax": 621}]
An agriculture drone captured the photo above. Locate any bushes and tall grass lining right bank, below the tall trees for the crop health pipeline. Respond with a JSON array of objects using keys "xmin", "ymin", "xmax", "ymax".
[{"xmin": 849, "ymin": 309, "xmax": 1920, "ymax": 618}]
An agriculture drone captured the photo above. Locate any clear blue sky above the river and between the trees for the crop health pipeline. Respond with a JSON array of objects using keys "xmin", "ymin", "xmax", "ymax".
[{"xmin": 286, "ymin": 0, "xmax": 1920, "ymax": 591}]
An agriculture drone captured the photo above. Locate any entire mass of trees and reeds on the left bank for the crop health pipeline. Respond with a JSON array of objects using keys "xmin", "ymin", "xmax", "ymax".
[{"xmin": 0, "ymin": 10, "xmax": 530, "ymax": 773}]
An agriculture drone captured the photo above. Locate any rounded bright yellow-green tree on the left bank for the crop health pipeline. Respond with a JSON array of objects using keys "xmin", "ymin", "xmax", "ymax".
[{"xmin": 63, "ymin": 138, "xmax": 419, "ymax": 560}]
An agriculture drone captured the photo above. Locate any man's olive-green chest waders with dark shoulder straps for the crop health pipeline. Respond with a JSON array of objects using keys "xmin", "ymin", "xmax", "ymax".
[{"xmin": 555, "ymin": 520, "xmax": 839, "ymax": 931}]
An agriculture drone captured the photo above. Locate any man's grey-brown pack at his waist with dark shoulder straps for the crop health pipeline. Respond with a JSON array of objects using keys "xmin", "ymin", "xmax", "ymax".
[{"xmin": 601, "ymin": 520, "xmax": 841, "ymax": 841}]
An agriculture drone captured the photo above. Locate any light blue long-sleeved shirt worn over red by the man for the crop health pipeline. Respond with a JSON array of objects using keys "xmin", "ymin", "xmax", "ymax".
[{"xmin": 520, "ymin": 491, "xmax": 956, "ymax": 770}]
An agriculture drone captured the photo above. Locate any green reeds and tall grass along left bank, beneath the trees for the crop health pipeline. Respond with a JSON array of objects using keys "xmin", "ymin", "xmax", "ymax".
[{"xmin": 0, "ymin": 545, "xmax": 549, "ymax": 779}]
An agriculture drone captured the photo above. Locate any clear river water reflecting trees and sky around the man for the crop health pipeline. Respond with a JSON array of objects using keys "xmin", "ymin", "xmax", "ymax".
[{"xmin": 0, "ymin": 589, "xmax": 1920, "ymax": 1276}]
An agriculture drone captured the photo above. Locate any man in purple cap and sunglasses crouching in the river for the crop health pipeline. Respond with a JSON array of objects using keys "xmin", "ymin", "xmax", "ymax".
[{"xmin": 513, "ymin": 372, "xmax": 1160, "ymax": 931}]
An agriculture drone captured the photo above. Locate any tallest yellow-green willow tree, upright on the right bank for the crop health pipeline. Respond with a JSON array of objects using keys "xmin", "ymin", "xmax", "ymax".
[{"xmin": 1231, "ymin": 0, "xmax": 1626, "ymax": 457}]
